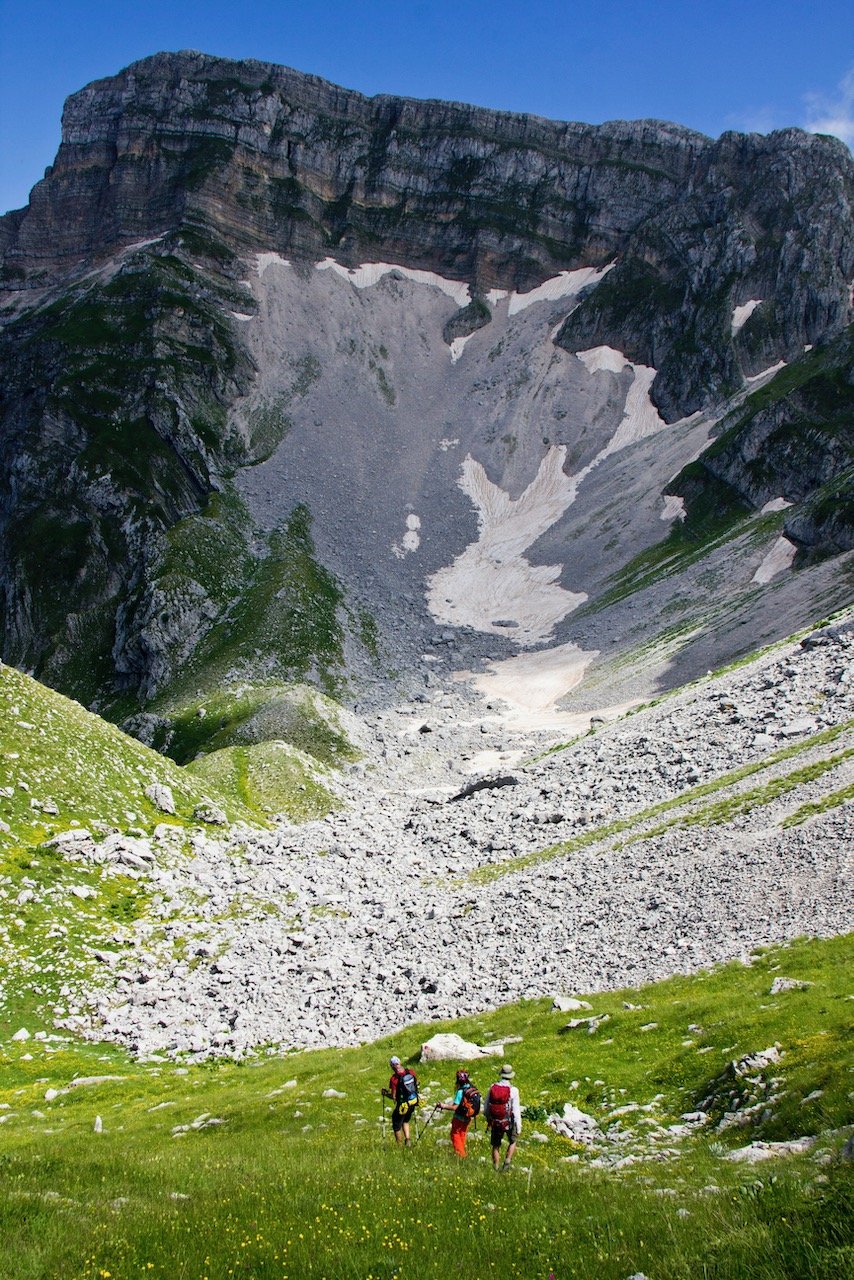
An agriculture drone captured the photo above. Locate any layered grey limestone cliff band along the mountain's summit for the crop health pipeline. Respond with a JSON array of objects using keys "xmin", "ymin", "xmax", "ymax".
[{"xmin": 0, "ymin": 52, "xmax": 854, "ymax": 417}]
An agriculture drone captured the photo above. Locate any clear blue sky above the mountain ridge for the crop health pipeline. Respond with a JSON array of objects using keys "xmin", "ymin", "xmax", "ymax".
[{"xmin": 0, "ymin": 0, "xmax": 854, "ymax": 211}]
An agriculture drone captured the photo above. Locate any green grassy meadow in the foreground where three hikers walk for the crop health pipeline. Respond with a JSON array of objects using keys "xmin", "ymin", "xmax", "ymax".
[{"xmin": 0, "ymin": 937, "xmax": 854, "ymax": 1280}]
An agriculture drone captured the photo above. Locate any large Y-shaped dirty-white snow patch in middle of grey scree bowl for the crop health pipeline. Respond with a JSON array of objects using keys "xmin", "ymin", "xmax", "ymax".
[{"xmin": 428, "ymin": 445, "xmax": 586, "ymax": 648}]
